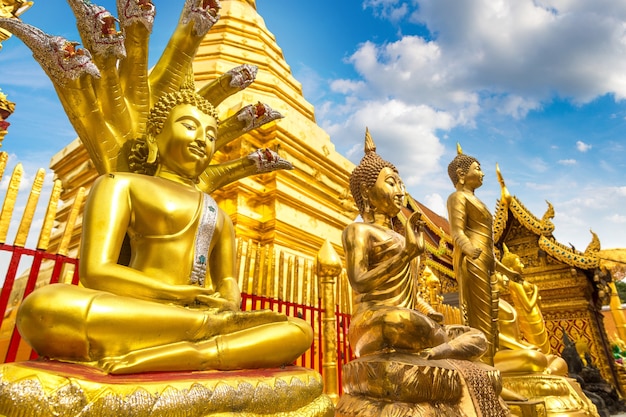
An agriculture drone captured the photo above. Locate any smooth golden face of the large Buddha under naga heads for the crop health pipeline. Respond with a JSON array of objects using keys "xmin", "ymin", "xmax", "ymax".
[{"xmin": 156, "ymin": 104, "xmax": 217, "ymax": 178}]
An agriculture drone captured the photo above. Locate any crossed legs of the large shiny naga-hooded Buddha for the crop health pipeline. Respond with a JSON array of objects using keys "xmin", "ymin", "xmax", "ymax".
[{"xmin": 18, "ymin": 284, "xmax": 313, "ymax": 373}]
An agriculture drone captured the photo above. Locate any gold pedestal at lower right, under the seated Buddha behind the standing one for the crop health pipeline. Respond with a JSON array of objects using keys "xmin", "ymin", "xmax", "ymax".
[{"xmin": 502, "ymin": 374, "xmax": 598, "ymax": 417}]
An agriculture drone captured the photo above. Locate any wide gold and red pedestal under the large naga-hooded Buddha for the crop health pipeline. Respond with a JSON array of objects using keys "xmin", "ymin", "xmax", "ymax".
[{"xmin": 0, "ymin": 360, "xmax": 334, "ymax": 417}]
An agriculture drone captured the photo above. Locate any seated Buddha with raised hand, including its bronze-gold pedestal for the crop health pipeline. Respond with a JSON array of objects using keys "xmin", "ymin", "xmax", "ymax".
[{"xmin": 335, "ymin": 131, "xmax": 508, "ymax": 417}]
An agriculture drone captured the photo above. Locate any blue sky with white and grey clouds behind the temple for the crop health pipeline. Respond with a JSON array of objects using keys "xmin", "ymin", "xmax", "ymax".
[{"xmin": 0, "ymin": 0, "xmax": 626, "ymax": 250}]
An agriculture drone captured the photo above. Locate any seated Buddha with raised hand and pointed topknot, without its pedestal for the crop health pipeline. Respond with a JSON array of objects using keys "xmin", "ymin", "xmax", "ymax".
[{"xmin": 342, "ymin": 131, "xmax": 486, "ymax": 359}]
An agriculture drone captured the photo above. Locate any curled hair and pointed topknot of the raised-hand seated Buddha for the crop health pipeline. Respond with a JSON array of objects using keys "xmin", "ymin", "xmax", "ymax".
[{"xmin": 350, "ymin": 128, "xmax": 398, "ymax": 214}]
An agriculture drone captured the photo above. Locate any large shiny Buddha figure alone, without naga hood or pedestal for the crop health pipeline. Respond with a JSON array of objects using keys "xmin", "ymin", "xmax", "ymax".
[{"xmin": 17, "ymin": 82, "xmax": 313, "ymax": 373}]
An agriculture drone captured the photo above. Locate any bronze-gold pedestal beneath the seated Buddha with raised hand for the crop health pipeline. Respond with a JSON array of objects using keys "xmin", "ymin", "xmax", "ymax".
[{"xmin": 335, "ymin": 353, "xmax": 509, "ymax": 417}]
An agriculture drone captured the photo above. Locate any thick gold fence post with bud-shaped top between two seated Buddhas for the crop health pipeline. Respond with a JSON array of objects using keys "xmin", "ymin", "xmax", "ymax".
[{"xmin": 317, "ymin": 240, "xmax": 341, "ymax": 404}]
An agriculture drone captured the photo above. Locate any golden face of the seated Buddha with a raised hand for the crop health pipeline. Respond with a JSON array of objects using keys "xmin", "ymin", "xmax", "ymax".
[{"xmin": 369, "ymin": 167, "xmax": 405, "ymax": 217}]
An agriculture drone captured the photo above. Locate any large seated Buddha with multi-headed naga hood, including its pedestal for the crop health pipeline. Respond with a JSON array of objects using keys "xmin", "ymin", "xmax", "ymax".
[{"xmin": 0, "ymin": 0, "xmax": 333, "ymax": 416}]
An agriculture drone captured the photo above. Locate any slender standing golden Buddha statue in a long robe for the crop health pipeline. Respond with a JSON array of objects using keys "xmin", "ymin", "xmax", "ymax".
[{"xmin": 447, "ymin": 146, "xmax": 519, "ymax": 365}]
